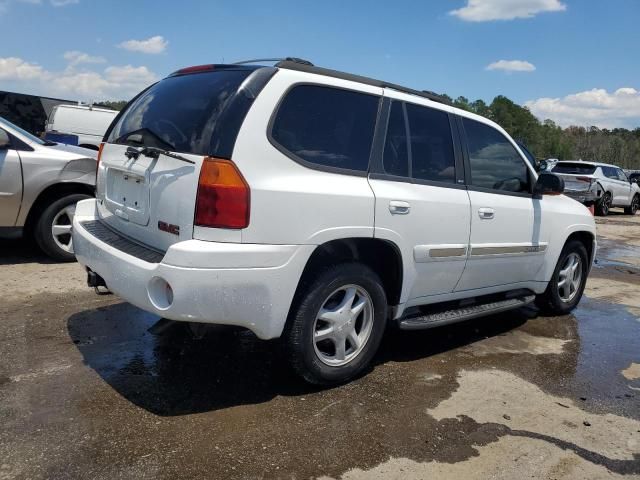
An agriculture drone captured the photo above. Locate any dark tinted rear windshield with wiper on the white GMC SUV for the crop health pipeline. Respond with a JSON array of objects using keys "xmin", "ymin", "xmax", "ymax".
[{"xmin": 107, "ymin": 69, "xmax": 252, "ymax": 155}]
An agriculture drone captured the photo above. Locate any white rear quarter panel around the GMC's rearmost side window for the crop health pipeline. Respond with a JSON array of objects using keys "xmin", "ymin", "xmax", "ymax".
[{"xmin": 232, "ymin": 69, "xmax": 382, "ymax": 245}]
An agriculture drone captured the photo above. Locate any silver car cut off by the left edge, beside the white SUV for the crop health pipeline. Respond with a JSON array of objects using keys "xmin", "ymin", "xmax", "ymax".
[{"xmin": 0, "ymin": 117, "xmax": 98, "ymax": 261}]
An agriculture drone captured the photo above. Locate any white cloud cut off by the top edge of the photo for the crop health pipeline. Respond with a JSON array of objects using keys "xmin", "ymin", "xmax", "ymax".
[{"xmin": 449, "ymin": 0, "xmax": 567, "ymax": 22}]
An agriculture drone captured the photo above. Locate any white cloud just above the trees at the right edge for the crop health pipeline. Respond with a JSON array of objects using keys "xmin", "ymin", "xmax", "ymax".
[{"xmin": 525, "ymin": 87, "xmax": 640, "ymax": 128}]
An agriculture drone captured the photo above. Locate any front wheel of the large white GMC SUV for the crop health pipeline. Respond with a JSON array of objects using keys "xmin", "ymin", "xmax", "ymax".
[{"xmin": 536, "ymin": 240, "xmax": 589, "ymax": 315}]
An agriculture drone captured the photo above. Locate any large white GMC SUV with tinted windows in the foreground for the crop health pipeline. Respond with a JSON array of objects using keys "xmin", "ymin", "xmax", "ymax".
[{"xmin": 73, "ymin": 59, "xmax": 596, "ymax": 384}]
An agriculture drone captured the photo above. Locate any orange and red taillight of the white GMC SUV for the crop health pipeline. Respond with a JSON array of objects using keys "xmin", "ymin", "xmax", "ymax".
[{"xmin": 195, "ymin": 157, "xmax": 251, "ymax": 228}]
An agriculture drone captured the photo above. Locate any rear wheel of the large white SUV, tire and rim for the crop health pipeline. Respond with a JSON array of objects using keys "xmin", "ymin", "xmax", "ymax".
[{"xmin": 282, "ymin": 263, "xmax": 388, "ymax": 385}]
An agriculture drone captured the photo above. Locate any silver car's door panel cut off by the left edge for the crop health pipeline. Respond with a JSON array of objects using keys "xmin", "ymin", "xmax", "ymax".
[{"xmin": 0, "ymin": 129, "xmax": 22, "ymax": 227}]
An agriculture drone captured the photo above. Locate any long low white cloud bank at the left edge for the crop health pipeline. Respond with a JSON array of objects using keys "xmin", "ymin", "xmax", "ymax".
[{"xmin": 0, "ymin": 52, "xmax": 157, "ymax": 101}]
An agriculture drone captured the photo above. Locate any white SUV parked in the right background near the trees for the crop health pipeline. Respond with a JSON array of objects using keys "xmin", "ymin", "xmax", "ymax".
[{"xmin": 551, "ymin": 160, "xmax": 640, "ymax": 216}]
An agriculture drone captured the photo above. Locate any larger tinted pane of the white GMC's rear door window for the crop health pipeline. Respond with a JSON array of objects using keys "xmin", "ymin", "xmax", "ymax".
[{"xmin": 407, "ymin": 103, "xmax": 456, "ymax": 183}]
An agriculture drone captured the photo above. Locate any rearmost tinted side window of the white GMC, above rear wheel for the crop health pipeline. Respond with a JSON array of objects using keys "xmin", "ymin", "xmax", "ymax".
[{"xmin": 271, "ymin": 85, "xmax": 379, "ymax": 172}]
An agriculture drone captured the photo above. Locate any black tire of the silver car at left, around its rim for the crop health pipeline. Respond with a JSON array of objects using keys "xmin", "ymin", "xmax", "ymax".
[{"xmin": 34, "ymin": 193, "xmax": 91, "ymax": 262}]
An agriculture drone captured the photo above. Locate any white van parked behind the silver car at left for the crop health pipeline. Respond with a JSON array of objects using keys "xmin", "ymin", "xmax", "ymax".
[{"xmin": 44, "ymin": 105, "xmax": 118, "ymax": 150}]
